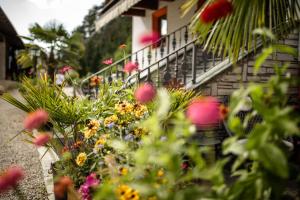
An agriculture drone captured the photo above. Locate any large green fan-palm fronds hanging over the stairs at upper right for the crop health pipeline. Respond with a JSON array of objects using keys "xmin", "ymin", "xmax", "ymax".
[{"xmin": 182, "ymin": 0, "xmax": 300, "ymax": 59}]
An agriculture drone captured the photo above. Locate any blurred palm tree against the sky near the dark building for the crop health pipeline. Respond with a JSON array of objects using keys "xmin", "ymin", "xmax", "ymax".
[{"xmin": 18, "ymin": 21, "xmax": 85, "ymax": 76}]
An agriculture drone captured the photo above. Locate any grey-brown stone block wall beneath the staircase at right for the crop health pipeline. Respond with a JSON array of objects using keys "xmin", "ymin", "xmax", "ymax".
[{"xmin": 197, "ymin": 31, "xmax": 300, "ymax": 99}]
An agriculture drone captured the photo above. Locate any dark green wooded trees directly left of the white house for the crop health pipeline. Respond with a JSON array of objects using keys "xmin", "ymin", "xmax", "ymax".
[{"xmin": 75, "ymin": 4, "xmax": 132, "ymax": 74}]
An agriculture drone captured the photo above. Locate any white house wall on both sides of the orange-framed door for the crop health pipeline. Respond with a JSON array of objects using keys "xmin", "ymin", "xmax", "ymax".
[{"xmin": 132, "ymin": 0, "xmax": 195, "ymax": 52}]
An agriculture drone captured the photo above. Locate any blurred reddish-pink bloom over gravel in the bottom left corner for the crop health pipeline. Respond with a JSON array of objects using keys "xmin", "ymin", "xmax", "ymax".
[{"xmin": 0, "ymin": 166, "xmax": 24, "ymax": 193}]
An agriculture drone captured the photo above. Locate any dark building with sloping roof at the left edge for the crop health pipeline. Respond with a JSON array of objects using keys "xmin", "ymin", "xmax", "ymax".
[{"xmin": 0, "ymin": 7, "xmax": 24, "ymax": 80}]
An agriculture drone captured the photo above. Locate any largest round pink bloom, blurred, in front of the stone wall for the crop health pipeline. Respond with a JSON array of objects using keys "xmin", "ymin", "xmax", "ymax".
[{"xmin": 187, "ymin": 97, "xmax": 220, "ymax": 127}]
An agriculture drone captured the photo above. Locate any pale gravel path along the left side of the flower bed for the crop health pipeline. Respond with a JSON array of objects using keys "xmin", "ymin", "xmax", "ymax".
[{"xmin": 0, "ymin": 91, "xmax": 47, "ymax": 200}]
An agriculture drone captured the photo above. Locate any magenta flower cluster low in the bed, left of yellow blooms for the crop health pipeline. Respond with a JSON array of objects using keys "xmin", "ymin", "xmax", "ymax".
[{"xmin": 79, "ymin": 173, "xmax": 100, "ymax": 200}]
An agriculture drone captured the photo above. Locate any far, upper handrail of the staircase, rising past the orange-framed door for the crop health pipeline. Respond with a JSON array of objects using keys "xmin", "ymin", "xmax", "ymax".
[{"xmin": 80, "ymin": 23, "xmax": 190, "ymax": 89}]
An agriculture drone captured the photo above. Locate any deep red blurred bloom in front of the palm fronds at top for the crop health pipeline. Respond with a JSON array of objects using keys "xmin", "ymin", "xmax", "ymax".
[{"xmin": 200, "ymin": 0, "xmax": 233, "ymax": 24}]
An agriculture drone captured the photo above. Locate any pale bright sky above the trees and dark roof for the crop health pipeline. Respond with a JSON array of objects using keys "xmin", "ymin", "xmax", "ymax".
[{"xmin": 0, "ymin": 0, "xmax": 103, "ymax": 36}]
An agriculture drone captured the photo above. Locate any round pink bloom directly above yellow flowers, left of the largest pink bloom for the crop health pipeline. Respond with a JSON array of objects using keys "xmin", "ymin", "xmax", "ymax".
[{"xmin": 134, "ymin": 83, "xmax": 156, "ymax": 104}]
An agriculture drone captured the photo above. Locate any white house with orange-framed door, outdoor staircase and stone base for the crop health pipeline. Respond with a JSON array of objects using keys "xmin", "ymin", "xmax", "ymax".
[{"xmin": 92, "ymin": 0, "xmax": 300, "ymax": 98}]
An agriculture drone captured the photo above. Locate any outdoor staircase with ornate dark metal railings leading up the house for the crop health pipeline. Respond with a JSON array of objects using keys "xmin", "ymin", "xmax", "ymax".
[{"xmin": 81, "ymin": 21, "xmax": 298, "ymax": 93}]
